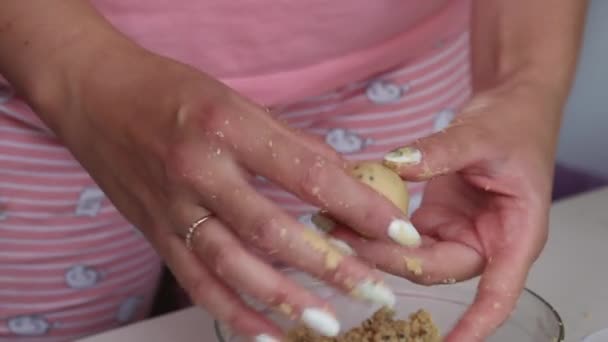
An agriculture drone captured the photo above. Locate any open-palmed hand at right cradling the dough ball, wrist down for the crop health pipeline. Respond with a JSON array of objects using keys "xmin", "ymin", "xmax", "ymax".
[{"xmin": 333, "ymin": 78, "xmax": 563, "ymax": 342}]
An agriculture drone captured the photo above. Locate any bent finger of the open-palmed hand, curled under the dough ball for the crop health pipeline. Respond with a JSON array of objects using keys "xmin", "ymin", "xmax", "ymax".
[{"xmin": 331, "ymin": 228, "xmax": 484, "ymax": 285}]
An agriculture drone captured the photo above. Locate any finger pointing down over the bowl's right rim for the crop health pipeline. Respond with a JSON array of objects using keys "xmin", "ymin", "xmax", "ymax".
[{"xmin": 446, "ymin": 253, "xmax": 529, "ymax": 342}]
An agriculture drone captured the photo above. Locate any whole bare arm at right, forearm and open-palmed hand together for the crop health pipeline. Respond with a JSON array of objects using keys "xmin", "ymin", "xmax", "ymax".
[{"xmin": 335, "ymin": 0, "xmax": 586, "ymax": 342}]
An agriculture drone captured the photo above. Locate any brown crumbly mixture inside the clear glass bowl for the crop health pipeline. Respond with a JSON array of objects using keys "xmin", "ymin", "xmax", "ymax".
[{"xmin": 285, "ymin": 308, "xmax": 441, "ymax": 342}]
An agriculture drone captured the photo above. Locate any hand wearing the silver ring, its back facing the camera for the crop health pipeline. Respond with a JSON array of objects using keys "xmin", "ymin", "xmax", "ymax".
[{"xmin": 25, "ymin": 36, "xmax": 417, "ymax": 340}]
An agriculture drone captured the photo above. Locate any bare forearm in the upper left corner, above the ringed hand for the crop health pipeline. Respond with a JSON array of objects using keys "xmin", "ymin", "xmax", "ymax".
[{"xmin": 0, "ymin": 0, "xmax": 134, "ymax": 119}]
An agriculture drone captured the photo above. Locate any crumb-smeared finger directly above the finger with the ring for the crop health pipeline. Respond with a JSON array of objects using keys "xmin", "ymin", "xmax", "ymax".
[{"xmin": 198, "ymin": 162, "xmax": 394, "ymax": 306}]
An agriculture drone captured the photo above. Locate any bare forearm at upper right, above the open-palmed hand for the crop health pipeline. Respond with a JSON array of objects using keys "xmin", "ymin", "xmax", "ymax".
[{"xmin": 472, "ymin": 0, "xmax": 587, "ymax": 98}]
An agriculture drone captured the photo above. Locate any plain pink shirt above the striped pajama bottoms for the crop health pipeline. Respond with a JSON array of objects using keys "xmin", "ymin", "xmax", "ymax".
[{"xmin": 92, "ymin": 0, "xmax": 470, "ymax": 104}]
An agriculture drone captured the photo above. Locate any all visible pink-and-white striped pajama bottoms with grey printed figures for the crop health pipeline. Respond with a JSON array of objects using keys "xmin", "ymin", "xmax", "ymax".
[{"xmin": 0, "ymin": 32, "xmax": 471, "ymax": 342}]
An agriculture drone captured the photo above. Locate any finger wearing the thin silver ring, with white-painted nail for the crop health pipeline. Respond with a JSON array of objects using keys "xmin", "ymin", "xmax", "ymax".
[{"xmin": 193, "ymin": 211, "xmax": 340, "ymax": 337}]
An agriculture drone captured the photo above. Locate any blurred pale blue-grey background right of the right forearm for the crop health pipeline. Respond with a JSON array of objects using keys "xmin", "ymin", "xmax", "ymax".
[{"xmin": 555, "ymin": 0, "xmax": 608, "ymax": 197}]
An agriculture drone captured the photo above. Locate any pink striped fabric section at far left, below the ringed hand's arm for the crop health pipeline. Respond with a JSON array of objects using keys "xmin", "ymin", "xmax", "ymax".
[{"xmin": 0, "ymin": 101, "xmax": 161, "ymax": 342}]
